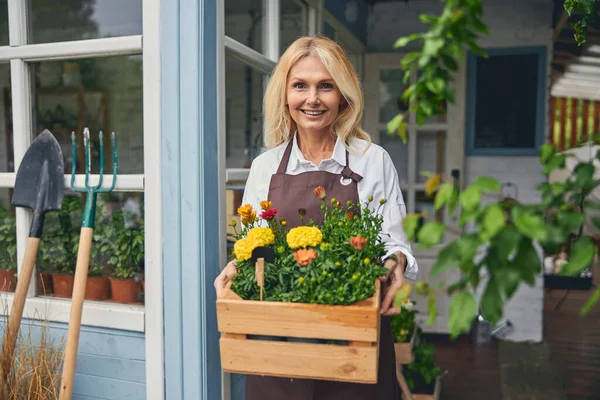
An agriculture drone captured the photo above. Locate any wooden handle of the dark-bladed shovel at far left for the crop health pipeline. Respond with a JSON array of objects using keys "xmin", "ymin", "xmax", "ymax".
[{"xmin": 0, "ymin": 237, "xmax": 40, "ymax": 386}]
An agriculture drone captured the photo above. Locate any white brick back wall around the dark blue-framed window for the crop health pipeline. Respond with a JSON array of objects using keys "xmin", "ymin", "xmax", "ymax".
[{"xmin": 367, "ymin": 0, "xmax": 553, "ymax": 341}]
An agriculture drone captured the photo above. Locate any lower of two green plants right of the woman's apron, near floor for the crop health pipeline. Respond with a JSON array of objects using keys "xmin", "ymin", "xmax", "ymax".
[{"xmin": 402, "ymin": 341, "xmax": 440, "ymax": 400}]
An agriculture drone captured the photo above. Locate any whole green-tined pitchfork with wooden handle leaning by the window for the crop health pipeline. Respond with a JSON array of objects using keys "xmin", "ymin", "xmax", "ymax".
[{"xmin": 59, "ymin": 128, "xmax": 117, "ymax": 400}]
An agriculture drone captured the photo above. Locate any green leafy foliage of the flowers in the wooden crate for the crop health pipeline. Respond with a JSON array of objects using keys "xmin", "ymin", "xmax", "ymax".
[{"xmin": 232, "ymin": 195, "xmax": 387, "ymax": 305}]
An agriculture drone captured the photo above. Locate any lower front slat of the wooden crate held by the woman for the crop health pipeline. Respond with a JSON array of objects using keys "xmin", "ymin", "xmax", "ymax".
[{"xmin": 220, "ymin": 337, "xmax": 378, "ymax": 384}]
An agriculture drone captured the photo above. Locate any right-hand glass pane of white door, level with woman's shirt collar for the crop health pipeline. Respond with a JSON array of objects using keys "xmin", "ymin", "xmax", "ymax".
[{"xmin": 416, "ymin": 131, "xmax": 446, "ymax": 183}]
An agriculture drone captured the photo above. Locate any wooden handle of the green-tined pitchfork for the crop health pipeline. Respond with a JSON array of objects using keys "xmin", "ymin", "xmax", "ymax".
[{"xmin": 59, "ymin": 228, "xmax": 94, "ymax": 400}]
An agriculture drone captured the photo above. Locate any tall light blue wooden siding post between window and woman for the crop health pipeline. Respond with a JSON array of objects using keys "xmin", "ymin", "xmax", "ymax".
[{"xmin": 161, "ymin": 0, "xmax": 221, "ymax": 400}]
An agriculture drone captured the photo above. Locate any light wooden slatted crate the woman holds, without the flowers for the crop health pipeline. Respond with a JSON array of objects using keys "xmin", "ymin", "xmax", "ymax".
[{"xmin": 217, "ymin": 280, "xmax": 380, "ymax": 384}]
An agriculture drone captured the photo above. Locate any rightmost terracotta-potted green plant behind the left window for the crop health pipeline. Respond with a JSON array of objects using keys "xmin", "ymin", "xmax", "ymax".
[{"xmin": 108, "ymin": 210, "xmax": 144, "ymax": 303}]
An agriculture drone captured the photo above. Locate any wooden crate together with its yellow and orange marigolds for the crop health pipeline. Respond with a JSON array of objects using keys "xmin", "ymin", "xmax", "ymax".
[{"xmin": 217, "ymin": 187, "xmax": 394, "ymax": 383}]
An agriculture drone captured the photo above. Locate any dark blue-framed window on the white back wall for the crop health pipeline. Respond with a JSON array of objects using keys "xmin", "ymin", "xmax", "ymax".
[{"xmin": 467, "ymin": 48, "xmax": 546, "ymax": 155}]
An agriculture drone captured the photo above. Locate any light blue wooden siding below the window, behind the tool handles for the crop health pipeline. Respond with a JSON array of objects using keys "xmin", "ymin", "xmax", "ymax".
[{"xmin": 2, "ymin": 317, "xmax": 146, "ymax": 400}]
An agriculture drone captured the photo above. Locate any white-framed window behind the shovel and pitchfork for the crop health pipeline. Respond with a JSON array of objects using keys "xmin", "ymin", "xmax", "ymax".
[{"xmin": 0, "ymin": 0, "xmax": 145, "ymax": 331}]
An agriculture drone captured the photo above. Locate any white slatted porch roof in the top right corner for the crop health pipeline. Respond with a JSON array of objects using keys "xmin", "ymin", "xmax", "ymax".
[{"xmin": 551, "ymin": 0, "xmax": 600, "ymax": 100}]
